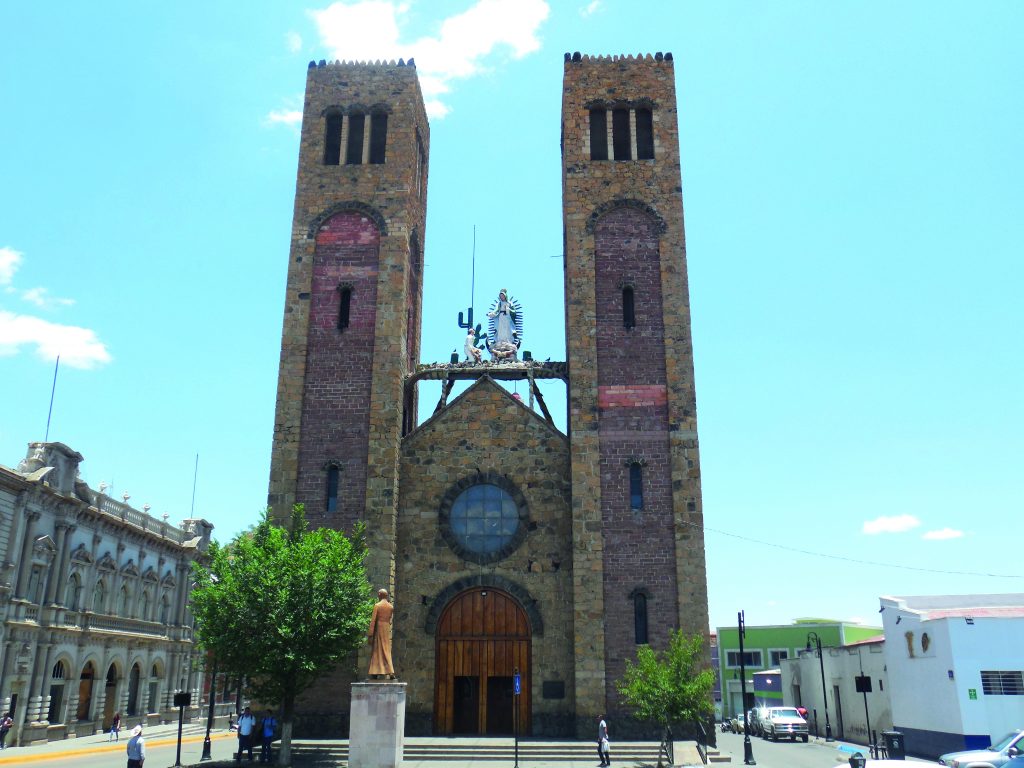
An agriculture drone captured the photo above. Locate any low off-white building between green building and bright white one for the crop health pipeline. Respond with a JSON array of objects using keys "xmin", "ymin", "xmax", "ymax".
[{"xmin": 780, "ymin": 635, "xmax": 893, "ymax": 744}]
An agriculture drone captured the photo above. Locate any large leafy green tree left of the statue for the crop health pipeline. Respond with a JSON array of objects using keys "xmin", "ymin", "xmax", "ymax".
[{"xmin": 191, "ymin": 505, "xmax": 373, "ymax": 765}]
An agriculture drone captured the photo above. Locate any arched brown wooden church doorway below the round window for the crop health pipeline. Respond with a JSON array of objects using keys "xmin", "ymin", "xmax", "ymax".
[{"xmin": 434, "ymin": 587, "xmax": 530, "ymax": 735}]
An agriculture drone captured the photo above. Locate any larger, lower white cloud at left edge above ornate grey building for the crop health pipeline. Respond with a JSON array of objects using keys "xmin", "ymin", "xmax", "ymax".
[{"xmin": 0, "ymin": 310, "xmax": 111, "ymax": 369}]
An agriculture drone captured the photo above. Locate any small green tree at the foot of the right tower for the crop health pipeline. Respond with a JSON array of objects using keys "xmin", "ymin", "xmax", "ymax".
[{"xmin": 617, "ymin": 630, "xmax": 715, "ymax": 728}]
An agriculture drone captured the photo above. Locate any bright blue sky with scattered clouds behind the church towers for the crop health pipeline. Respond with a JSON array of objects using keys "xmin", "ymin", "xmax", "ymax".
[{"xmin": 0, "ymin": 0, "xmax": 1024, "ymax": 625}]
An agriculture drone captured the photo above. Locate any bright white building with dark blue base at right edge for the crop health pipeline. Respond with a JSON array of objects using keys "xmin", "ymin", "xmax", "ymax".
[{"xmin": 881, "ymin": 594, "xmax": 1024, "ymax": 756}]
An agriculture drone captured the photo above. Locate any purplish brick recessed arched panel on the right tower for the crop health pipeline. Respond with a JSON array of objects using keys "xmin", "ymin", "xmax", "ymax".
[{"xmin": 594, "ymin": 208, "xmax": 679, "ymax": 720}]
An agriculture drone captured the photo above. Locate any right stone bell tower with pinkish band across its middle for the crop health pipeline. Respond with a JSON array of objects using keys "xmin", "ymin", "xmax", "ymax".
[{"xmin": 562, "ymin": 53, "xmax": 708, "ymax": 732}]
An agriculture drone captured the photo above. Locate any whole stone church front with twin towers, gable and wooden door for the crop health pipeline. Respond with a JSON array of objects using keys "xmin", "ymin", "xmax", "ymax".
[{"xmin": 269, "ymin": 53, "xmax": 708, "ymax": 735}]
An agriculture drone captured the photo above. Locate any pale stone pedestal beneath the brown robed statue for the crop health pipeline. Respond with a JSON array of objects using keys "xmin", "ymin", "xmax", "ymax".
[{"xmin": 348, "ymin": 680, "xmax": 406, "ymax": 768}]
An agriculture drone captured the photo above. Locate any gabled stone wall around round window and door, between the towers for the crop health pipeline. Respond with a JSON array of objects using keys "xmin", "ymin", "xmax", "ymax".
[{"xmin": 394, "ymin": 379, "xmax": 577, "ymax": 735}]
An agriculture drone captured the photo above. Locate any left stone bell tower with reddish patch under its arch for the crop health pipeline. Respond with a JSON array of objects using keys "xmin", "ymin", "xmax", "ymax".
[{"xmin": 268, "ymin": 59, "xmax": 430, "ymax": 602}]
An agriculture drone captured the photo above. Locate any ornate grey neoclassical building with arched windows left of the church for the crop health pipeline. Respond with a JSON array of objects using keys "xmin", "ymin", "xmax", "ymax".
[{"xmin": 0, "ymin": 442, "xmax": 213, "ymax": 744}]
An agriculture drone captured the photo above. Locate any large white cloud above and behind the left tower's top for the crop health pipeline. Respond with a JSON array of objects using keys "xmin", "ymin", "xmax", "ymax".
[{"xmin": 310, "ymin": 0, "xmax": 550, "ymax": 118}]
